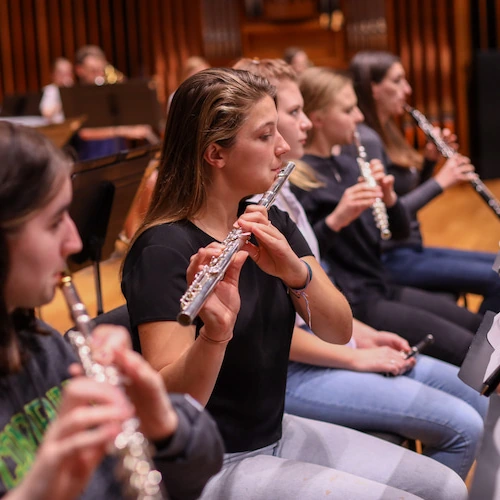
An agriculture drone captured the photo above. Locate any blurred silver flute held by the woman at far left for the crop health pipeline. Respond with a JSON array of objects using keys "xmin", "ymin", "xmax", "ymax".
[{"xmin": 59, "ymin": 273, "xmax": 166, "ymax": 500}]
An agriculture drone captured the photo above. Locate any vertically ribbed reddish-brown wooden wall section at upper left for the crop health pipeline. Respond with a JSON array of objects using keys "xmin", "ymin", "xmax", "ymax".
[{"xmin": 0, "ymin": 0, "xmax": 205, "ymax": 111}]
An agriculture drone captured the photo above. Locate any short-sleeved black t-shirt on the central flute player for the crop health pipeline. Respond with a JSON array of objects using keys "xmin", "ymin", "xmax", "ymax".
[{"xmin": 122, "ymin": 206, "xmax": 312, "ymax": 452}]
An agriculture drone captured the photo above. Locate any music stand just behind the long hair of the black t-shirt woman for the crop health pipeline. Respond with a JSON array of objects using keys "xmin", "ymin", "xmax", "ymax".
[{"xmin": 68, "ymin": 146, "xmax": 159, "ymax": 314}]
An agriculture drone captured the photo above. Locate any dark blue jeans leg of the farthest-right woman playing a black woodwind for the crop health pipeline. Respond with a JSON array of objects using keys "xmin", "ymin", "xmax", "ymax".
[{"xmin": 382, "ymin": 247, "xmax": 500, "ymax": 313}]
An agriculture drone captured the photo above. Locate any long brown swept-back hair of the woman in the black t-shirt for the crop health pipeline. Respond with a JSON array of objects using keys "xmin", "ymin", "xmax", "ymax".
[{"xmin": 134, "ymin": 68, "xmax": 276, "ymax": 246}]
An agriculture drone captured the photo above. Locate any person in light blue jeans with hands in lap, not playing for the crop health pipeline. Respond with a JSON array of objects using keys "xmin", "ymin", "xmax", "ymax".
[{"xmin": 234, "ymin": 59, "xmax": 488, "ymax": 479}]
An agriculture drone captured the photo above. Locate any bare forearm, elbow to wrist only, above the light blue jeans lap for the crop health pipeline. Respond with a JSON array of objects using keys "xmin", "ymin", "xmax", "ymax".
[{"xmin": 290, "ymin": 327, "xmax": 355, "ymax": 370}]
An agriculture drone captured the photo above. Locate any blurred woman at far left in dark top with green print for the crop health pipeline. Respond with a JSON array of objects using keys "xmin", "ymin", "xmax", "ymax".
[{"xmin": 0, "ymin": 122, "xmax": 224, "ymax": 500}]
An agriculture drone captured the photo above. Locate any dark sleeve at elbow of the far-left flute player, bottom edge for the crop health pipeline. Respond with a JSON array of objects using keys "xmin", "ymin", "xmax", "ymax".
[{"xmin": 154, "ymin": 394, "xmax": 224, "ymax": 500}]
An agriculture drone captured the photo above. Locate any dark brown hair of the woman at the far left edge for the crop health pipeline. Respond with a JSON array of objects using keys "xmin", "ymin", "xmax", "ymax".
[{"xmin": 0, "ymin": 122, "xmax": 72, "ymax": 375}]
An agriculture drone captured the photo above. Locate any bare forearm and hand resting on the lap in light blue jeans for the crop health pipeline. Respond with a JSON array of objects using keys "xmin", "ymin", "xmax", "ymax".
[{"xmin": 290, "ymin": 327, "xmax": 415, "ymax": 375}]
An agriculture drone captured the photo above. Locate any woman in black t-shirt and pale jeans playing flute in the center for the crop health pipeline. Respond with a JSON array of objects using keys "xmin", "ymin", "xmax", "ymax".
[{"xmin": 122, "ymin": 68, "xmax": 466, "ymax": 500}]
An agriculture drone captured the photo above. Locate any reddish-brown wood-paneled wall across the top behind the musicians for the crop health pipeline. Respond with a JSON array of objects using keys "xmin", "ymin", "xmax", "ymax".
[{"xmin": 0, "ymin": 0, "xmax": 500, "ymax": 160}]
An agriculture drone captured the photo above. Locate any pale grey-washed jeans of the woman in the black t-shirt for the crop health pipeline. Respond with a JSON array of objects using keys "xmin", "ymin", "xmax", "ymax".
[{"xmin": 200, "ymin": 414, "xmax": 467, "ymax": 500}]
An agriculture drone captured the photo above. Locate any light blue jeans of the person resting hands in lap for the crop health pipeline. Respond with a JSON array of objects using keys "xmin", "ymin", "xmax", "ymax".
[{"xmin": 285, "ymin": 356, "xmax": 488, "ymax": 478}]
